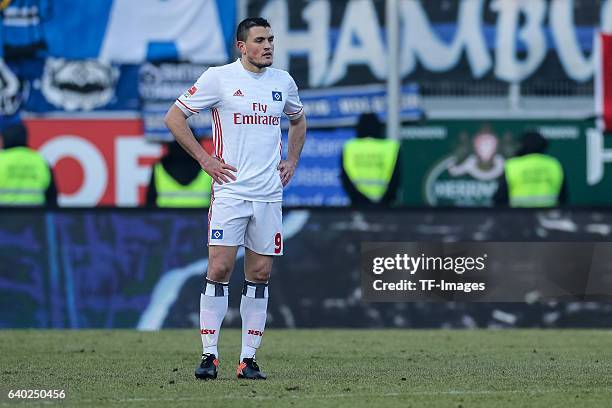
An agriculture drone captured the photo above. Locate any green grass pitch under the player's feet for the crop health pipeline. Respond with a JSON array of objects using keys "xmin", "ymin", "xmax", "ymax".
[{"xmin": 0, "ymin": 329, "xmax": 612, "ymax": 408}]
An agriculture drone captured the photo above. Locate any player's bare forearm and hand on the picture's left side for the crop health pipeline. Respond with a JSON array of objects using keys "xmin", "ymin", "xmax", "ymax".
[{"xmin": 164, "ymin": 105, "xmax": 237, "ymax": 184}]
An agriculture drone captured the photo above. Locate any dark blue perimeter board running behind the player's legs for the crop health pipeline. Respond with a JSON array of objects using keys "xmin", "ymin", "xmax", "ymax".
[{"xmin": 0, "ymin": 209, "xmax": 612, "ymax": 330}]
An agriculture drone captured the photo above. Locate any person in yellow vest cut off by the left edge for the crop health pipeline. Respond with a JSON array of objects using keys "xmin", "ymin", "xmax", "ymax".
[{"xmin": 0, "ymin": 123, "xmax": 57, "ymax": 207}]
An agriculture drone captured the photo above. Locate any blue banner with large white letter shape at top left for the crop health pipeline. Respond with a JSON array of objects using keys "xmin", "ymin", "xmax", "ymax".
[{"xmin": 2, "ymin": 0, "xmax": 236, "ymax": 64}]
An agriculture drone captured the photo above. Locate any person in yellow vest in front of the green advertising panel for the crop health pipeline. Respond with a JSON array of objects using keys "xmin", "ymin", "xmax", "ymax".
[{"xmin": 493, "ymin": 131, "xmax": 567, "ymax": 208}]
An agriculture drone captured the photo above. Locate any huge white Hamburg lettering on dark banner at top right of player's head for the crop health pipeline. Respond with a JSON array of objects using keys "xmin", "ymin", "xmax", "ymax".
[{"xmin": 260, "ymin": 0, "xmax": 612, "ymax": 86}]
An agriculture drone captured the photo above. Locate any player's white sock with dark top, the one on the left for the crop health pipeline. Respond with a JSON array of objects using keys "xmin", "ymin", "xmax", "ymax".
[{"xmin": 200, "ymin": 279, "xmax": 228, "ymax": 358}]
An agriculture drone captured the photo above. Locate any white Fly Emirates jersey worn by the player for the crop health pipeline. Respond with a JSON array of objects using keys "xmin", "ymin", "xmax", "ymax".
[{"xmin": 175, "ymin": 60, "xmax": 303, "ymax": 202}]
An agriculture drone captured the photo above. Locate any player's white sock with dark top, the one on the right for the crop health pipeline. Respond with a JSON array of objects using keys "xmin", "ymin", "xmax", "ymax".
[{"xmin": 240, "ymin": 280, "xmax": 268, "ymax": 361}]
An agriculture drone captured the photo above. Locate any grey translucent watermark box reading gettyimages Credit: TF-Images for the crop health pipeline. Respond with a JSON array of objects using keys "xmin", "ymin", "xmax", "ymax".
[{"xmin": 361, "ymin": 242, "xmax": 612, "ymax": 302}]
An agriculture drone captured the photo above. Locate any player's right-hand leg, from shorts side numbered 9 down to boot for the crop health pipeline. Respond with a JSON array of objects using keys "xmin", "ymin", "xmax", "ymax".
[{"xmin": 238, "ymin": 202, "xmax": 282, "ymax": 379}]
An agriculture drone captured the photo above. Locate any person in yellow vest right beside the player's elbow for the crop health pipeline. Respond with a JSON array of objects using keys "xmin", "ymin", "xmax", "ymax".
[{"xmin": 146, "ymin": 142, "xmax": 212, "ymax": 208}]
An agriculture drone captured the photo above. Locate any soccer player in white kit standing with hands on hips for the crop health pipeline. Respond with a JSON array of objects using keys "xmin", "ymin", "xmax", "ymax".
[{"xmin": 165, "ymin": 18, "xmax": 306, "ymax": 379}]
